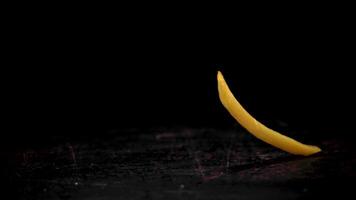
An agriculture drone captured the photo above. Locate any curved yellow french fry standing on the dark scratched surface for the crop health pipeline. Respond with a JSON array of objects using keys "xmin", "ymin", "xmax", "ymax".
[{"xmin": 218, "ymin": 71, "xmax": 321, "ymax": 156}]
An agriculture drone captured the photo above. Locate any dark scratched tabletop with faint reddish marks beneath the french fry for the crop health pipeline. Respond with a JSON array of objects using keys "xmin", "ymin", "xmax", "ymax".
[{"xmin": 5, "ymin": 128, "xmax": 356, "ymax": 200}]
